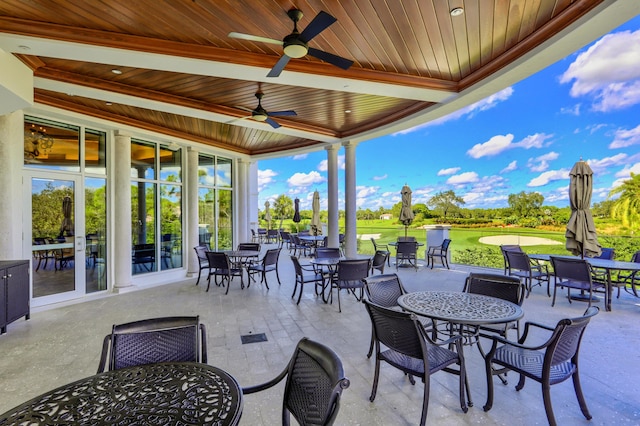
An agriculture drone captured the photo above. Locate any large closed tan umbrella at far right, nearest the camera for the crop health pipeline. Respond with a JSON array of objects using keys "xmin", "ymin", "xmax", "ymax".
[{"xmin": 565, "ymin": 160, "xmax": 602, "ymax": 257}]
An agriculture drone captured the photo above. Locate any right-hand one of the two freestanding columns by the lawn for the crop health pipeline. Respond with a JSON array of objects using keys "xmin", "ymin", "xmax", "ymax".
[{"xmin": 342, "ymin": 142, "xmax": 358, "ymax": 257}]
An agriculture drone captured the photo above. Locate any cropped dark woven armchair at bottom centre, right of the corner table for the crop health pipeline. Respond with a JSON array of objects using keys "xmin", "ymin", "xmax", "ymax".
[{"xmin": 242, "ymin": 337, "xmax": 350, "ymax": 425}]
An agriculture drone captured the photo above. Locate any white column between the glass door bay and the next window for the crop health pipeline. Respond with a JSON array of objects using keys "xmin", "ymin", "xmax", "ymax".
[{"xmin": 112, "ymin": 132, "xmax": 132, "ymax": 292}]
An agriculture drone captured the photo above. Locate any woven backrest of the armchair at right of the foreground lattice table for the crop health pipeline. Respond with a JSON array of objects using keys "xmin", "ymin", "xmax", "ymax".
[{"xmin": 544, "ymin": 306, "xmax": 600, "ymax": 367}]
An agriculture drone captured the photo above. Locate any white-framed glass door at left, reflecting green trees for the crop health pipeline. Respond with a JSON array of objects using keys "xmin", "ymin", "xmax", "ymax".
[{"xmin": 27, "ymin": 172, "xmax": 85, "ymax": 306}]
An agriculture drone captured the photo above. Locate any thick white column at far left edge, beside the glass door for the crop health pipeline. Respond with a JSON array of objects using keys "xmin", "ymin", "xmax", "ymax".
[{"xmin": 0, "ymin": 111, "xmax": 24, "ymax": 260}]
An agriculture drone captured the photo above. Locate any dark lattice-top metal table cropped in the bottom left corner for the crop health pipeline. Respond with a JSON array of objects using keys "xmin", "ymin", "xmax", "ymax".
[{"xmin": 0, "ymin": 362, "xmax": 243, "ymax": 425}]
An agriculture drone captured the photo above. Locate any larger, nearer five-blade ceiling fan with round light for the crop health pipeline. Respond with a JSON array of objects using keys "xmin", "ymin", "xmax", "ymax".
[{"xmin": 229, "ymin": 9, "xmax": 353, "ymax": 77}]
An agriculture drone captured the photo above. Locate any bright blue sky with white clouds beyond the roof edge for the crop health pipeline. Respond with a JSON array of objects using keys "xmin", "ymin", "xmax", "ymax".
[{"xmin": 258, "ymin": 17, "xmax": 640, "ymax": 210}]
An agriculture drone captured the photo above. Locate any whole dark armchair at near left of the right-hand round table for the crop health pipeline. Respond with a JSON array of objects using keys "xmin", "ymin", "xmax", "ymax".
[{"xmin": 364, "ymin": 299, "xmax": 468, "ymax": 426}]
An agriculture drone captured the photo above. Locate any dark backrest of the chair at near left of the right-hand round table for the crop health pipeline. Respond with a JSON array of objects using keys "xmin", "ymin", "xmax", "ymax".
[{"xmin": 363, "ymin": 299, "xmax": 430, "ymax": 362}]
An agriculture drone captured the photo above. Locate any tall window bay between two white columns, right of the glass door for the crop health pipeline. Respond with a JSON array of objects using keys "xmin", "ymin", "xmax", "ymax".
[{"xmin": 131, "ymin": 140, "xmax": 183, "ymax": 275}]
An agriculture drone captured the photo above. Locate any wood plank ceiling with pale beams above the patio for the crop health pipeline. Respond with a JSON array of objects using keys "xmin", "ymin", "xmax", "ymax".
[{"xmin": 0, "ymin": 0, "xmax": 601, "ymax": 155}]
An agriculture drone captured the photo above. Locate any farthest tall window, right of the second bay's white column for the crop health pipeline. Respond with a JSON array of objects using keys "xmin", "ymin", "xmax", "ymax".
[{"xmin": 198, "ymin": 155, "xmax": 234, "ymax": 250}]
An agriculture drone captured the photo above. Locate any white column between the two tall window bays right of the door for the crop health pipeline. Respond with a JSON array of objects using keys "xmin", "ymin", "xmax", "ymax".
[{"xmin": 184, "ymin": 147, "xmax": 200, "ymax": 276}]
